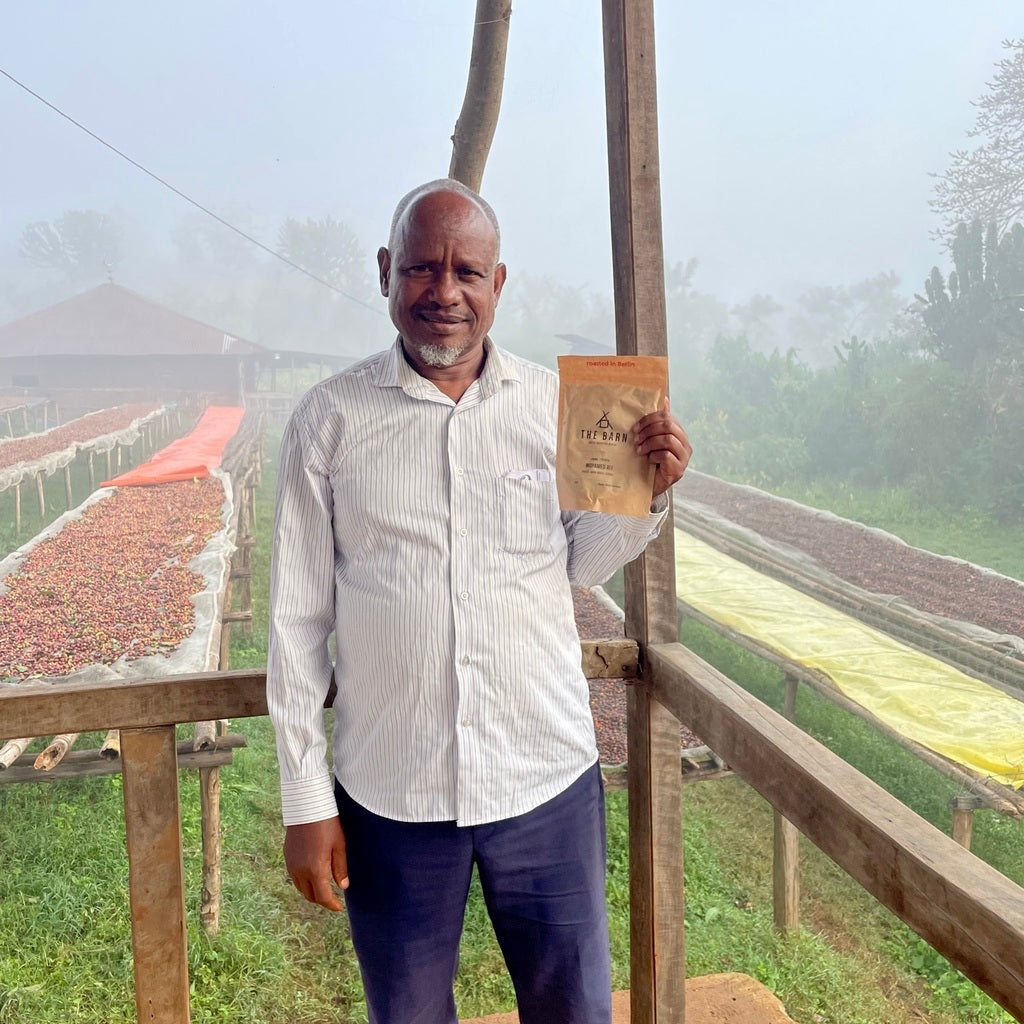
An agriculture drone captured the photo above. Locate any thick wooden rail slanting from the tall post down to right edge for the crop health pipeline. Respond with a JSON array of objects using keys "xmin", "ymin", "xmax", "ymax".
[{"xmin": 645, "ymin": 644, "xmax": 1024, "ymax": 1020}]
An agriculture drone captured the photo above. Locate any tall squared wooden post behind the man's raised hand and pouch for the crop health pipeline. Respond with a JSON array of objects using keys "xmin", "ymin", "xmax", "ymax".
[{"xmin": 603, "ymin": 0, "xmax": 686, "ymax": 1024}]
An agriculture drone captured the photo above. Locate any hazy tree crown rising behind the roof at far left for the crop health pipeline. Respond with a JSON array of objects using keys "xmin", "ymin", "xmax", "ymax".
[{"xmin": 18, "ymin": 210, "xmax": 123, "ymax": 285}]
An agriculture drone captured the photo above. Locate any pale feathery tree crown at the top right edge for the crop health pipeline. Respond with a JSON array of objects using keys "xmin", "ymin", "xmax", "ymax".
[{"xmin": 931, "ymin": 39, "xmax": 1024, "ymax": 233}]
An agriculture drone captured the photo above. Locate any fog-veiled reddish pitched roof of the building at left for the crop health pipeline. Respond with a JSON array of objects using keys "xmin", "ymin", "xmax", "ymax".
[{"xmin": 0, "ymin": 284, "xmax": 266, "ymax": 358}]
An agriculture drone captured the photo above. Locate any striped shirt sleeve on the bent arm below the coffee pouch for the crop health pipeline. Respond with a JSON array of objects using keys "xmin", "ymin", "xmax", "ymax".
[{"xmin": 562, "ymin": 495, "xmax": 669, "ymax": 587}]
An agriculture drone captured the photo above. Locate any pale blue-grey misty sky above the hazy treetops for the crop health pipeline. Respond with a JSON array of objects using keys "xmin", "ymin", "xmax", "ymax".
[{"xmin": 0, "ymin": 0, "xmax": 1024, "ymax": 309}]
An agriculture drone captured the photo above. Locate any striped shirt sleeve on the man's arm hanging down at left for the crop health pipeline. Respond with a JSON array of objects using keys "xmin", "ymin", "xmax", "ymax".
[{"xmin": 266, "ymin": 412, "xmax": 338, "ymax": 825}]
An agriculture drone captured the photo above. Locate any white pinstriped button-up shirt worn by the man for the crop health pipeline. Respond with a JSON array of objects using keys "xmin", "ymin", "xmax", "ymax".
[{"xmin": 267, "ymin": 340, "xmax": 665, "ymax": 825}]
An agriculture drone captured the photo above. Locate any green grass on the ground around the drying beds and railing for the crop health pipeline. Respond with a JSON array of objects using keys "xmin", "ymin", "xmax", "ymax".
[{"xmin": 0, "ymin": 445, "xmax": 1024, "ymax": 1024}]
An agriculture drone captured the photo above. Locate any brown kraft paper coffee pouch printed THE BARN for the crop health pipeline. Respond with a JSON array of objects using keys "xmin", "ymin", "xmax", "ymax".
[{"xmin": 556, "ymin": 355, "xmax": 669, "ymax": 516}]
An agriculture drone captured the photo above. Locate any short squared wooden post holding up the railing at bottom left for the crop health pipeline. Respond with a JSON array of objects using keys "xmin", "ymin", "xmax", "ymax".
[{"xmin": 121, "ymin": 725, "xmax": 190, "ymax": 1024}]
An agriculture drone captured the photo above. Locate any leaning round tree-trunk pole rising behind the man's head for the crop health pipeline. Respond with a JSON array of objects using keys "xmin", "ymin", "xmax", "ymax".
[{"xmin": 449, "ymin": 0, "xmax": 512, "ymax": 191}]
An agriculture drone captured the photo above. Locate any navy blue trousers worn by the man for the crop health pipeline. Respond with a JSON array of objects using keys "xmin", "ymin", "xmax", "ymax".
[{"xmin": 335, "ymin": 765, "xmax": 611, "ymax": 1024}]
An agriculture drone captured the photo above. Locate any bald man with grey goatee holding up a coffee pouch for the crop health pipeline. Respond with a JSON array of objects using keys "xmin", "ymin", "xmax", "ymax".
[{"xmin": 267, "ymin": 180, "xmax": 690, "ymax": 1024}]
